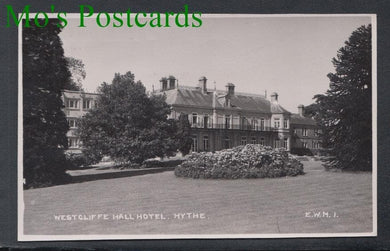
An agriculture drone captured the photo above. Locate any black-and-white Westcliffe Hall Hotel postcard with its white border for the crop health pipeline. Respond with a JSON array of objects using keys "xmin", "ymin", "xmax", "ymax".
[{"xmin": 17, "ymin": 12, "xmax": 377, "ymax": 241}]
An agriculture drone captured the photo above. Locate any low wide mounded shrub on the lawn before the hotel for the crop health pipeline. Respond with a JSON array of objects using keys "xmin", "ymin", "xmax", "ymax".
[{"xmin": 175, "ymin": 145, "xmax": 304, "ymax": 179}]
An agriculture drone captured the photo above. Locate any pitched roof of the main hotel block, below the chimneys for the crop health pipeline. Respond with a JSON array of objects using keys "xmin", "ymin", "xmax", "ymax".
[{"xmin": 155, "ymin": 87, "xmax": 290, "ymax": 113}]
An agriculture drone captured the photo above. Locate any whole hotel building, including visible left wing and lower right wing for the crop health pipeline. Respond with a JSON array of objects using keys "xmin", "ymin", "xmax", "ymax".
[{"xmin": 63, "ymin": 77, "xmax": 318, "ymax": 153}]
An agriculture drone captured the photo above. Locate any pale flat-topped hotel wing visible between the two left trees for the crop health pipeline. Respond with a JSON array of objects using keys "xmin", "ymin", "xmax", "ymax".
[{"xmin": 62, "ymin": 91, "xmax": 98, "ymax": 153}]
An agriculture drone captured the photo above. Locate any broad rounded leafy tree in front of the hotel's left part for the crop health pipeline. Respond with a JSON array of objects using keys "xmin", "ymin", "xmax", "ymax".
[{"xmin": 80, "ymin": 72, "xmax": 186, "ymax": 164}]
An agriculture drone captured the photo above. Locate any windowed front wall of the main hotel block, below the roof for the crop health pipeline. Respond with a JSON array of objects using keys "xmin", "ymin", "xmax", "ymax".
[{"xmin": 170, "ymin": 106, "xmax": 291, "ymax": 152}]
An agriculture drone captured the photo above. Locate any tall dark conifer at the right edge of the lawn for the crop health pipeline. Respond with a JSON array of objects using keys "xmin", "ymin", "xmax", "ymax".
[{"xmin": 309, "ymin": 25, "xmax": 372, "ymax": 170}]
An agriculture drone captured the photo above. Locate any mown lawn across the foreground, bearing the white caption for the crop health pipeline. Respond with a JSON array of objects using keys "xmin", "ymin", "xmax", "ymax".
[{"xmin": 24, "ymin": 161, "xmax": 372, "ymax": 235}]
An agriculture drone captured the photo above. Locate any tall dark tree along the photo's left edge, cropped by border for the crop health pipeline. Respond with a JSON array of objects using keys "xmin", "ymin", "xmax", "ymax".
[{"xmin": 23, "ymin": 20, "xmax": 70, "ymax": 188}]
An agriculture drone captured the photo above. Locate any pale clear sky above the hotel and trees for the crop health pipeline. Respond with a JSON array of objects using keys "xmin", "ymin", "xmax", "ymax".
[{"xmin": 60, "ymin": 15, "xmax": 371, "ymax": 113}]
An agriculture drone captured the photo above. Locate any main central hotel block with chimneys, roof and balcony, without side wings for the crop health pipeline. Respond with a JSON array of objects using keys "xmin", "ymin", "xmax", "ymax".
[{"xmin": 154, "ymin": 77, "xmax": 291, "ymax": 151}]
